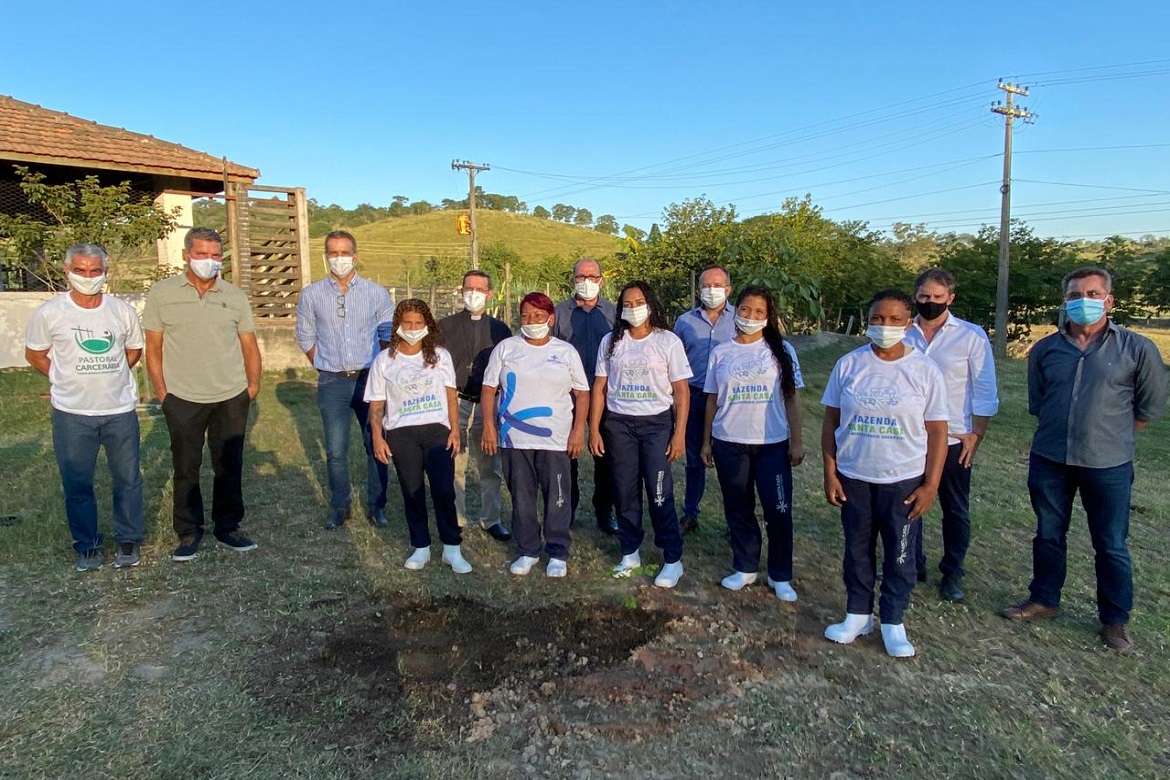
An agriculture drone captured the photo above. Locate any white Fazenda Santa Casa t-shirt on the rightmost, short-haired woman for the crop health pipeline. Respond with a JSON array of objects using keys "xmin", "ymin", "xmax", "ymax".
[{"xmin": 820, "ymin": 344, "xmax": 948, "ymax": 484}]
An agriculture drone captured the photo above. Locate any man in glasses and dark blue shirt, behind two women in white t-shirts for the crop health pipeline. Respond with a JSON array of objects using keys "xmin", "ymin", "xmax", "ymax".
[{"xmin": 552, "ymin": 257, "xmax": 618, "ymax": 536}]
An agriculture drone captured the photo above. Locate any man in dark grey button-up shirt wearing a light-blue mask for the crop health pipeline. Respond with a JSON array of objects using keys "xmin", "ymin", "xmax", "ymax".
[{"xmin": 1003, "ymin": 268, "xmax": 1166, "ymax": 653}]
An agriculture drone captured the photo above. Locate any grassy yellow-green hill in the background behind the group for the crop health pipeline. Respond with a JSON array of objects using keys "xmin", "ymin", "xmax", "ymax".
[{"xmin": 310, "ymin": 210, "xmax": 624, "ymax": 285}]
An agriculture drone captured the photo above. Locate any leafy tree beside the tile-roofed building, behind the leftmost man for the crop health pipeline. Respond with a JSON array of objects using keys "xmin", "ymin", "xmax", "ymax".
[{"xmin": 0, "ymin": 165, "xmax": 179, "ymax": 289}]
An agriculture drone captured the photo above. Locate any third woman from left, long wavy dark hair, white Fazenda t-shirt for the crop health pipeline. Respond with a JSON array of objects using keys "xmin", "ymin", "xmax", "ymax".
[{"xmin": 590, "ymin": 282, "xmax": 691, "ymax": 588}]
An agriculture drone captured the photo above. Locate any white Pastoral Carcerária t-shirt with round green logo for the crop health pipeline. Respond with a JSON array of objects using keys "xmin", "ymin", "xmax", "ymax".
[{"xmin": 25, "ymin": 292, "xmax": 144, "ymax": 416}]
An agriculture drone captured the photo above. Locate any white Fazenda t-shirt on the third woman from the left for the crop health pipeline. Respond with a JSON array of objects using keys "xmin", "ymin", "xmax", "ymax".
[{"xmin": 597, "ymin": 330, "xmax": 694, "ymax": 416}]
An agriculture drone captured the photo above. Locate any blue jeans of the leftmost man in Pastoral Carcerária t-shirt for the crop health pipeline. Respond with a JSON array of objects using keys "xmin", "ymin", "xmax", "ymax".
[{"xmin": 51, "ymin": 409, "xmax": 145, "ymax": 552}]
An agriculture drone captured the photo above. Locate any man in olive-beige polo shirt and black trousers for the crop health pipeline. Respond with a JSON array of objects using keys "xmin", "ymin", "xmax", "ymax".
[{"xmin": 143, "ymin": 228, "xmax": 260, "ymax": 560}]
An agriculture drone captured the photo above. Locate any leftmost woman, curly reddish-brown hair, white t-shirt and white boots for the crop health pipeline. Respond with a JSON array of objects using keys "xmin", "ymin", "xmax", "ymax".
[{"xmin": 365, "ymin": 298, "xmax": 472, "ymax": 574}]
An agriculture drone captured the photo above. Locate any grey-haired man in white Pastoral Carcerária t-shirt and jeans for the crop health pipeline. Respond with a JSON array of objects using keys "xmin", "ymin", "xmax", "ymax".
[{"xmin": 25, "ymin": 243, "xmax": 144, "ymax": 572}]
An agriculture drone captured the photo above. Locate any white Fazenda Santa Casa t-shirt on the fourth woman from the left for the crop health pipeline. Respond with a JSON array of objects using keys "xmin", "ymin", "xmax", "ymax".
[{"xmin": 691, "ymin": 339, "xmax": 804, "ymax": 444}]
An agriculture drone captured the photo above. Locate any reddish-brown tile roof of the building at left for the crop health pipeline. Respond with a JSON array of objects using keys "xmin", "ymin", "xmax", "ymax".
[{"xmin": 0, "ymin": 95, "xmax": 260, "ymax": 182}]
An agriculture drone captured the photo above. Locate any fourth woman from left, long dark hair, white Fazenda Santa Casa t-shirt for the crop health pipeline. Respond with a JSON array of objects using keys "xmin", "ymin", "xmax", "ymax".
[{"xmin": 702, "ymin": 285, "xmax": 804, "ymax": 601}]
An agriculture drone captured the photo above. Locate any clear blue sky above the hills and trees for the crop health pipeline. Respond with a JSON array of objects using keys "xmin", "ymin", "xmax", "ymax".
[{"xmin": 9, "ymin": 0, "xmax": 1170, "ymax": 237}]
